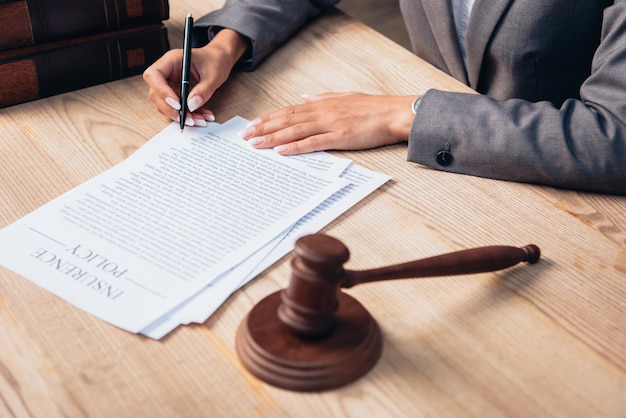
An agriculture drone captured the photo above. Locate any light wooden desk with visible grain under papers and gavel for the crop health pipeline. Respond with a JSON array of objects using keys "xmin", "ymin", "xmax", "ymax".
[{"xmin": 0, "ymin": 0, "xmax": 626, "ymax": 418}]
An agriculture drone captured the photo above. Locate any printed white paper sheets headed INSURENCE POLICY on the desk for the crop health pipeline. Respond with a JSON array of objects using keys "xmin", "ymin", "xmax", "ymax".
[{"xmin": 0, "ymin": 117, "xmax": 389, "ymax": 339}]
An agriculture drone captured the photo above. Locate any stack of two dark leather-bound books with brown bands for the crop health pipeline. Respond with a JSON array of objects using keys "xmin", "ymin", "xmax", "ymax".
[{"xmin": 0, "ymin": 0, "xmax": 169, "ymax": 108}]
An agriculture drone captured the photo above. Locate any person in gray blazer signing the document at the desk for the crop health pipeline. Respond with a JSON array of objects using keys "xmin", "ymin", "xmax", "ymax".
[{"xmin": 144, "ymin": 0, "xmax": 626, "ymax": 194}]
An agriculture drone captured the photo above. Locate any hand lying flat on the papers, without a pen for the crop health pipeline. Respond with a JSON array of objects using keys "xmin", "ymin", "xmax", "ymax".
[{"xmin": 241, "ymin": 93, "xmax": 416, "ymax": 155}]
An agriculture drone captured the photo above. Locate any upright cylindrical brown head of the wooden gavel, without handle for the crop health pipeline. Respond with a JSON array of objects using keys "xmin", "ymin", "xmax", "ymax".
[{"xmin": 278, "ymin": 234, "xmax": 350, "ymax": 337}]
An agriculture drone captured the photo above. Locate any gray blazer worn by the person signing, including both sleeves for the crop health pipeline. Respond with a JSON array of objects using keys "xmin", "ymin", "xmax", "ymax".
[{"xmin": 196, "ymin": 0, "xmax": 626, "ymax": 194}]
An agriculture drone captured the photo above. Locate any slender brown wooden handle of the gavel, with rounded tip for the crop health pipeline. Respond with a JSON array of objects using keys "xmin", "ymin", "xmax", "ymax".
[{"xmin": 341, "ymin": 244, "xmax": 541, "ymax": 288}]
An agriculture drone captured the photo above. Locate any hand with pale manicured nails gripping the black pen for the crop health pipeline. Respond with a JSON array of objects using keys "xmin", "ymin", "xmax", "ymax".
[{"xmin": 143, "ymin": 29, "xmax": 248, "ymax": 126}]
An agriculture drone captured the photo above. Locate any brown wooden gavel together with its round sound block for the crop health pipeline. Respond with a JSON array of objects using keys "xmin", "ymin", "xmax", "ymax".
[{"xmin": 236, "ymin": 234, "xmax": 540, "ymax": 391}]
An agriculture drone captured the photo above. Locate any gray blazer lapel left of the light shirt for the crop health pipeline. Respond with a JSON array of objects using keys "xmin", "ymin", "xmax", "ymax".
[{"xmin": 422, "ymin": 0, "xmax": 468, "ymax": 83}]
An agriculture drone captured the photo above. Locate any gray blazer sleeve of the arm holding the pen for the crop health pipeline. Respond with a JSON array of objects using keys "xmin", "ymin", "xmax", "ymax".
[{"xmin": 194, "ymin": 0, "xmax": 339, "ymax": 70}]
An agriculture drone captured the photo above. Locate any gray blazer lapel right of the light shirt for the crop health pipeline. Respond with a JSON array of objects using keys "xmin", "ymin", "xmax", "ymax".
[{"xmin": 465, "ymin": 0, "xmax": 514, "ymax": 88}]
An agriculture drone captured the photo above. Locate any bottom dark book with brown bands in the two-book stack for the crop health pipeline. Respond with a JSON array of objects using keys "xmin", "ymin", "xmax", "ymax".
[{"xmin": 0, "ymin": 24, "xmax": 169, "ymax": 108}]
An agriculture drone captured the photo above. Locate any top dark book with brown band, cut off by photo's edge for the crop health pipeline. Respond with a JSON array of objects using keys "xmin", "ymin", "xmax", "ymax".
[{"xmin": 0, "ymin": 0, "xmax": 169, "ymax": 50}]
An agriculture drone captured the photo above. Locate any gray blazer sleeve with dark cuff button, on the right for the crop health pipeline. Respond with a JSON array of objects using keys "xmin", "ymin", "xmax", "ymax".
[{"xmin": 408, "ymin": 0, "xmax": 626, "ymax": 194}]
